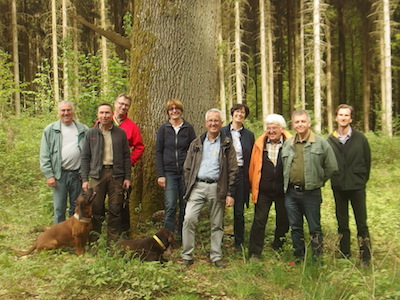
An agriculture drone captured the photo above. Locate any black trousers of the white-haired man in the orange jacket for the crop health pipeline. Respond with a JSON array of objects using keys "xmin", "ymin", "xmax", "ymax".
[{"xmin": 249, "ymin": 194, "xmax": 289, "ymax": 256}]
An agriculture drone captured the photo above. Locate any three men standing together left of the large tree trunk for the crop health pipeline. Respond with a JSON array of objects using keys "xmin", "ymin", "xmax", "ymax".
[{"xmin": 40, "ymin": 94, "xmax": 145, "ymax": 242}]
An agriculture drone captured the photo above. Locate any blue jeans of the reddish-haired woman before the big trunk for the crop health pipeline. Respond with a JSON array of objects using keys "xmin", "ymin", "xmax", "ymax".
[{"xmin": 164, "ymin": 172, "xmax": 186, "ymax": 236}]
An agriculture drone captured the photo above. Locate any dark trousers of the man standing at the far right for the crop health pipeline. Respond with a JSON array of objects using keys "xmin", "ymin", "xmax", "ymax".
[{"xmin": 333, "ymin": 190, "xmax": 371, "ymax": 260}]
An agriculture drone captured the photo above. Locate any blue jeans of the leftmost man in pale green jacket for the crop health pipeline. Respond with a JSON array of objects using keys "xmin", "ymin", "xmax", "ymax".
[{"xmin": 53, "ymin": 170, "xmax": 82, "ymax": 224}]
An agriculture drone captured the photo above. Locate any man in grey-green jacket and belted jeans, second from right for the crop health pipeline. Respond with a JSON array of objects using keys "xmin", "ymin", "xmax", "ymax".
[{"xmin": 282, "ymin": 109, "xmax": 337, "ymax": 263}]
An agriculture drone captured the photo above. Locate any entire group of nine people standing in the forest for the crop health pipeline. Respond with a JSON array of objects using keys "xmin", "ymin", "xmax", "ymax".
[{"xmin": 40, "ymin": 94, "xmax": 371, "ymax": 268}]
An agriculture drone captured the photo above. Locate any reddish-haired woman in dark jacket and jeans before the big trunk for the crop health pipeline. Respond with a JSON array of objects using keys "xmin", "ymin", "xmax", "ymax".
[{"xmin": 156, "ymin": 99, "xmax": 196, "ymax": 237}]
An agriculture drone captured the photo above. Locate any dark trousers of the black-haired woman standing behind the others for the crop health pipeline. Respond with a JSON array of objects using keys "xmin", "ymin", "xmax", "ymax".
[{"xmin": 233, "ymin": 167, "xmax": 247, "ymax": 247}]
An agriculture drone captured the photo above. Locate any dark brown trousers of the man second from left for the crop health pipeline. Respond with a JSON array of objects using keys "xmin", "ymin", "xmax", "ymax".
[{"xmin": 90, "ymin": 169, "xmax": 124, "ymax": 242}]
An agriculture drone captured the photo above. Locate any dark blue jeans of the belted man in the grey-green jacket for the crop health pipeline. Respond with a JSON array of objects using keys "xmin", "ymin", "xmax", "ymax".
[{"xmin": 285, "ymin": 186, "xmax": 322, "ymax": 259}]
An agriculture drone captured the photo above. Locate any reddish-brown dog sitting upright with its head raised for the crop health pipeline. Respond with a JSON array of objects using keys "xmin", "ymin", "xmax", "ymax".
[{"xmin": 17, "ymin": 188, "xmax": 96, "ymax": 255}]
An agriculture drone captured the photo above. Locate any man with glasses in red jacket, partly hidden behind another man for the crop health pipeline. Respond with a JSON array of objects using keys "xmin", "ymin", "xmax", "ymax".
[{"xmin": 113, "ymin": 94, "xmax": 144, "ymax": 239}]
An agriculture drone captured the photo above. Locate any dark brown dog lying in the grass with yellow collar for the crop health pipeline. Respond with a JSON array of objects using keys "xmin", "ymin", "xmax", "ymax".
[{"xmin": 116, "ymin": 228, "xmax": 174, "ymax": 262}]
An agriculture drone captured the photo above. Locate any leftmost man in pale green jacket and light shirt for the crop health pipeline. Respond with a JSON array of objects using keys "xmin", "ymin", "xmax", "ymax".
[{"xmin": 40, "ymin": 101, "xmax": 88, "ymax": 224}]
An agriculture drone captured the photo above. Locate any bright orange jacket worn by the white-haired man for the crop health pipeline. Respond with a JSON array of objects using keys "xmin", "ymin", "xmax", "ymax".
[{"xmin": 249, "ymin": 130, "xmax": 292, "ymax": 203}]
